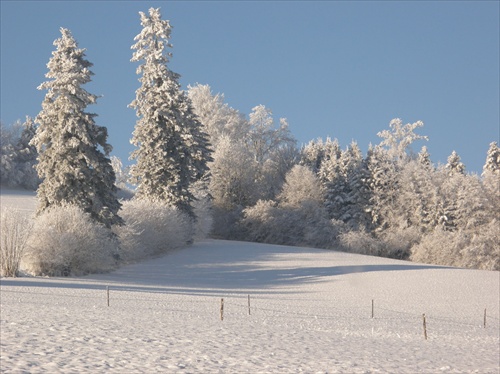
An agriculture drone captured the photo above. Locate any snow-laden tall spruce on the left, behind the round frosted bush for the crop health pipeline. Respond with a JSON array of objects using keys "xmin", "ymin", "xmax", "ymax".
[{"xmin": 31, "ymin": 28, "xmax": 122, "ymax": 227}]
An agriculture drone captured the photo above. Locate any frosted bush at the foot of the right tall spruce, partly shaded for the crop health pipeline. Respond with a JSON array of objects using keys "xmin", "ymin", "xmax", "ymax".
[{"xmin": 113, "ymin": 199, "xmax": 193, "ymax": 261}]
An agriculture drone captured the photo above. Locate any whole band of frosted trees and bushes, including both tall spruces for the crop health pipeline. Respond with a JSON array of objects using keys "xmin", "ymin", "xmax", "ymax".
[{"xmin": 1, "ymin": 9, "xmax": 500, "ymax": 275}]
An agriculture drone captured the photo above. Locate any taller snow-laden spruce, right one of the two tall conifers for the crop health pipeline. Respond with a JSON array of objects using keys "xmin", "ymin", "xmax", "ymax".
[{"xmin": 130, "ymin": 8, "xmax": 211, "ymax": 217}]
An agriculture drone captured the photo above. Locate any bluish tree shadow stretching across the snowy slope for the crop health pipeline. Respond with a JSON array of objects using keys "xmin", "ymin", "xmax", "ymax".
[{"xmin": 1, "ymin": 240, "xmax": 449, "ymax": 294}]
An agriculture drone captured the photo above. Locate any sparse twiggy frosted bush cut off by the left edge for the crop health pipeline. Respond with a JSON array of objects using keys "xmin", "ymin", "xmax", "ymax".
[{"xmin": 0, "ymin": 209, "xmax": 33, "ymax": 277}]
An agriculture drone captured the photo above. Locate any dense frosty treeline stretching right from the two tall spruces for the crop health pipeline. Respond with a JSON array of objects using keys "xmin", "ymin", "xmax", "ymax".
[{"xmin": 188, "ymin": 85, "xmax": 500, "ymax": 270}]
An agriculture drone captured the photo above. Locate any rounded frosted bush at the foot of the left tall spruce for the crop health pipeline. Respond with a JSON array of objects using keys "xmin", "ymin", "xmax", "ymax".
[{"xmin": 23, "ymin": 205, "xmax": 117, "ymax": 276}]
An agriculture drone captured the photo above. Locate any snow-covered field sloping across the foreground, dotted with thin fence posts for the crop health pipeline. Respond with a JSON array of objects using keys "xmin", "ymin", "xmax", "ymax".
[{"xmin": 0, "ymin": 194, "xmax": 500, "ymax": 373}]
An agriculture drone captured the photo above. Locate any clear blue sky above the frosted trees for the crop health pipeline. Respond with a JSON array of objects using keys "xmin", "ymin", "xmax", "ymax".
[{"xmin": 0, "ymin": 0, "xmax": 500, "ymax": 173}]
